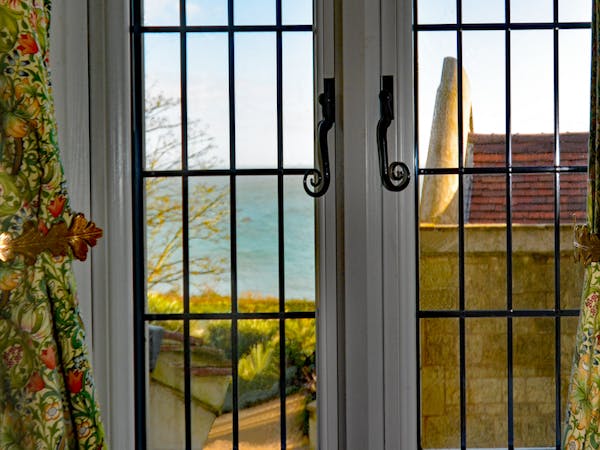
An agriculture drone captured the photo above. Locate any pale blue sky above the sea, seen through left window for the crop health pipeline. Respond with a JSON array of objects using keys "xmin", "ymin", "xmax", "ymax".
[{"xmin": 145, "ymin": 0, "xmax": 314, "ymax": 168}]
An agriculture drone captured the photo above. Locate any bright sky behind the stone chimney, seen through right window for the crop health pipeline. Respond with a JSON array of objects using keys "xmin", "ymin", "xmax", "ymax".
[{"xmin": 418, "ymin": 0, "xmax": 591, "ymax": 164}]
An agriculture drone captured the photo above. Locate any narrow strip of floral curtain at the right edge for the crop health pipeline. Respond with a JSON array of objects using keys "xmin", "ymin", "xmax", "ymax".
[{"xmin": 563, "ymin": 0, "xmax": 600, "ymax": 450}]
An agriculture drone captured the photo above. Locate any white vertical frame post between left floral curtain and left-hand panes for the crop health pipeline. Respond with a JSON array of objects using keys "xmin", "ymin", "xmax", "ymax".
[{"xmin": 87, "ymin": 0, "xmax": 135, "ymax": 449}]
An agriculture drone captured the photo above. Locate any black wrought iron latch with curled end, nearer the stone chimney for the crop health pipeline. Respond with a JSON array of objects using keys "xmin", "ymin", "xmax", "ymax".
[{"xmin": 377, "ymin": 75, "xmax": 410, "ymax": 192}]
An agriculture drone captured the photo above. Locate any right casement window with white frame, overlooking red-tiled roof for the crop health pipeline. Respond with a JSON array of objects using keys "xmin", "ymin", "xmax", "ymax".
[{"xmin": 343, "ymin": 1, "xmax": 591, "ymax": 449}]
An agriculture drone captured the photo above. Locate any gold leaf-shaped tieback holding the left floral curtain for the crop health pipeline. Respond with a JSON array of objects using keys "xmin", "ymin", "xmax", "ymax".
[{"xmin": 0, "ymin": 214, "xmax": 102, "ymax": 265}]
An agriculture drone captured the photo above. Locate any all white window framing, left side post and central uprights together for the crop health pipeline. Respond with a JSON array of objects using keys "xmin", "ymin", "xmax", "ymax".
[{"xmin": 58, "ymin": 0, "xmax": 418, "ymax": 450}]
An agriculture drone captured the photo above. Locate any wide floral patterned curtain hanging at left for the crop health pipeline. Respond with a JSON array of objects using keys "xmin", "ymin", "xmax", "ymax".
[{"xmin": 0, "ymin": 0, "xmax": 106, "ymax": 450}]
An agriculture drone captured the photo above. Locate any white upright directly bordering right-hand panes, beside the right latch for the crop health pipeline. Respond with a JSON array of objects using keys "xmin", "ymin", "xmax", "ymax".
[{"xmin": 383, "ymin": 0, "xmax": 419, "ymax": 449}]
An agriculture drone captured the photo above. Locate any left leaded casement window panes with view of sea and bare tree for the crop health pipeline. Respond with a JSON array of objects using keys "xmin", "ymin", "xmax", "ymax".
[{"xmin": 131, "ymin": 0, "xmax": 338, "ymax": 449}]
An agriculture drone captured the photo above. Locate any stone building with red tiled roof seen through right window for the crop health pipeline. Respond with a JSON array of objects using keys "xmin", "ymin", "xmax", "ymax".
[{"xmin": 419, "ymin": 59, "xmax": 588, "ymax": 449}]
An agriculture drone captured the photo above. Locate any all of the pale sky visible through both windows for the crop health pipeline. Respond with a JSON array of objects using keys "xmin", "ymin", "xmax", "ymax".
[{"xmin": 145, "ymin": 0, "xmax": 591, "ymax": 171}]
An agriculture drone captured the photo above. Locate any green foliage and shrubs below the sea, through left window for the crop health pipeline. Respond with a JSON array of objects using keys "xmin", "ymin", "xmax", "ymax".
[{"xmin": 148, "ymin": 291, "xmax": 316, "ymax": 410}]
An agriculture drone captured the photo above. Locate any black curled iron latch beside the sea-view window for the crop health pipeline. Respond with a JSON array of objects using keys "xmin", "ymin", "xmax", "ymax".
[{"xmin": 303, "ymin": 78, "xmax": 335, "ymax": 197}]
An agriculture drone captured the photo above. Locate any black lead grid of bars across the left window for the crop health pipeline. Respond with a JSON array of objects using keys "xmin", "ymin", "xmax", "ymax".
[{"xmin": 131, "ymin": 0, "xmax": 315, "ymax": 449}]
